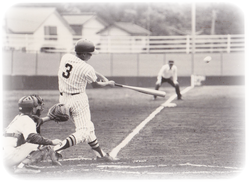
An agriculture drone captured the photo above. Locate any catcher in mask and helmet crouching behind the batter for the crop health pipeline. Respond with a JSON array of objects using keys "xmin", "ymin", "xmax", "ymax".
[{"xmin": 3, "ymin": 95, "xmax": 61, "ymax": 173}]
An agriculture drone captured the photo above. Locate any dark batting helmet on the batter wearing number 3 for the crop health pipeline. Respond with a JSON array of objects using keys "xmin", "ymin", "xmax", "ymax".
[{"xmin": 75, "ymin": 39, "xmax": 98, "ymax": 54}]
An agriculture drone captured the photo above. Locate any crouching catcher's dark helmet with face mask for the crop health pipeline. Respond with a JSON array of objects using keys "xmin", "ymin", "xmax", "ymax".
[{"xmin": 18, "ymin": 95, "xmax": 44, "ymax": 116}]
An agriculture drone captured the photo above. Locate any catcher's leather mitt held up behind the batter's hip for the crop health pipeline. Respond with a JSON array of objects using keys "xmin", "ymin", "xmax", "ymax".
[{"xmin": 47, "ymin": 103, "xmax": 70, "ymax": 122}]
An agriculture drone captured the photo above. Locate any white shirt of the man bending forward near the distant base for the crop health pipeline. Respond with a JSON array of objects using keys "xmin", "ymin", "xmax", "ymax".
[{"xmin": 157, "ymin": 64, "xmax": 177, "ymax": 82}]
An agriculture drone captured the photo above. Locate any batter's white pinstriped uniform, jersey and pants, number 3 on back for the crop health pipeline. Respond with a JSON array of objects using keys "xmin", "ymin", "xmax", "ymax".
[{"xmin": 58, "ymin": 54, "xmax": 97, "ymax": 145}]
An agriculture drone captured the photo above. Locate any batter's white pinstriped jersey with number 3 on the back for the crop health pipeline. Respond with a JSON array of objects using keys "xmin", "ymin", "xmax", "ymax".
[{"xmin": 58, "ymin": 54, "xmax": 97, "ymax": 94}]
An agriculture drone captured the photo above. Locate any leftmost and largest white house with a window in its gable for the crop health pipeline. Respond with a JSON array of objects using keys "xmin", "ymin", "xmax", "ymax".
[{"xmin": 2, "ymin": 7, "xmax": 75, "ymax": 51}]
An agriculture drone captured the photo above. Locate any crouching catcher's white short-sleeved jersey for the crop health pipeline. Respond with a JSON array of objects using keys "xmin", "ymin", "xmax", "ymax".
[{"xmin": 3, "ymin": 114, "xmax": 37, "ymax": 147}]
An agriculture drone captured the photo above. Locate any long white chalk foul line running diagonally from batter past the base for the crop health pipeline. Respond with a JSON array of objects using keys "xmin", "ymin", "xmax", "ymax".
[{"xmin": 110, "ymin": 86, "xmax": 193, "ymax": 157}]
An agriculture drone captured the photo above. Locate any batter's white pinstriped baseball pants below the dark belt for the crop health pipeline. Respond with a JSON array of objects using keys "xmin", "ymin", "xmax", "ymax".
[{"xmin": 59, "ymin": 93, "xmax": 96, "ymax": 144}]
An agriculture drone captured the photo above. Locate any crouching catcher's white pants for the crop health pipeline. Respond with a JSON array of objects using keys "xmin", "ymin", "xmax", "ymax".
[{"xmin": 3, "ymin": 143, "xmax": 39, "ymax": 167}]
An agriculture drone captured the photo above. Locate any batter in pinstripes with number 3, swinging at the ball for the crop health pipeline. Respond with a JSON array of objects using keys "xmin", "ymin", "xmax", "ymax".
[{"xmin": 54, "ymin": 39, "xmax": 116, "ymax": 161}]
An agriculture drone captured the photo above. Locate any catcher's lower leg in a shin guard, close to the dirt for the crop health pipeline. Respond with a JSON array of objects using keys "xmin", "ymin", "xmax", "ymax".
[{"xmin": 22, "ymin": 146, "xmax": 62, "ymax": 166}]
